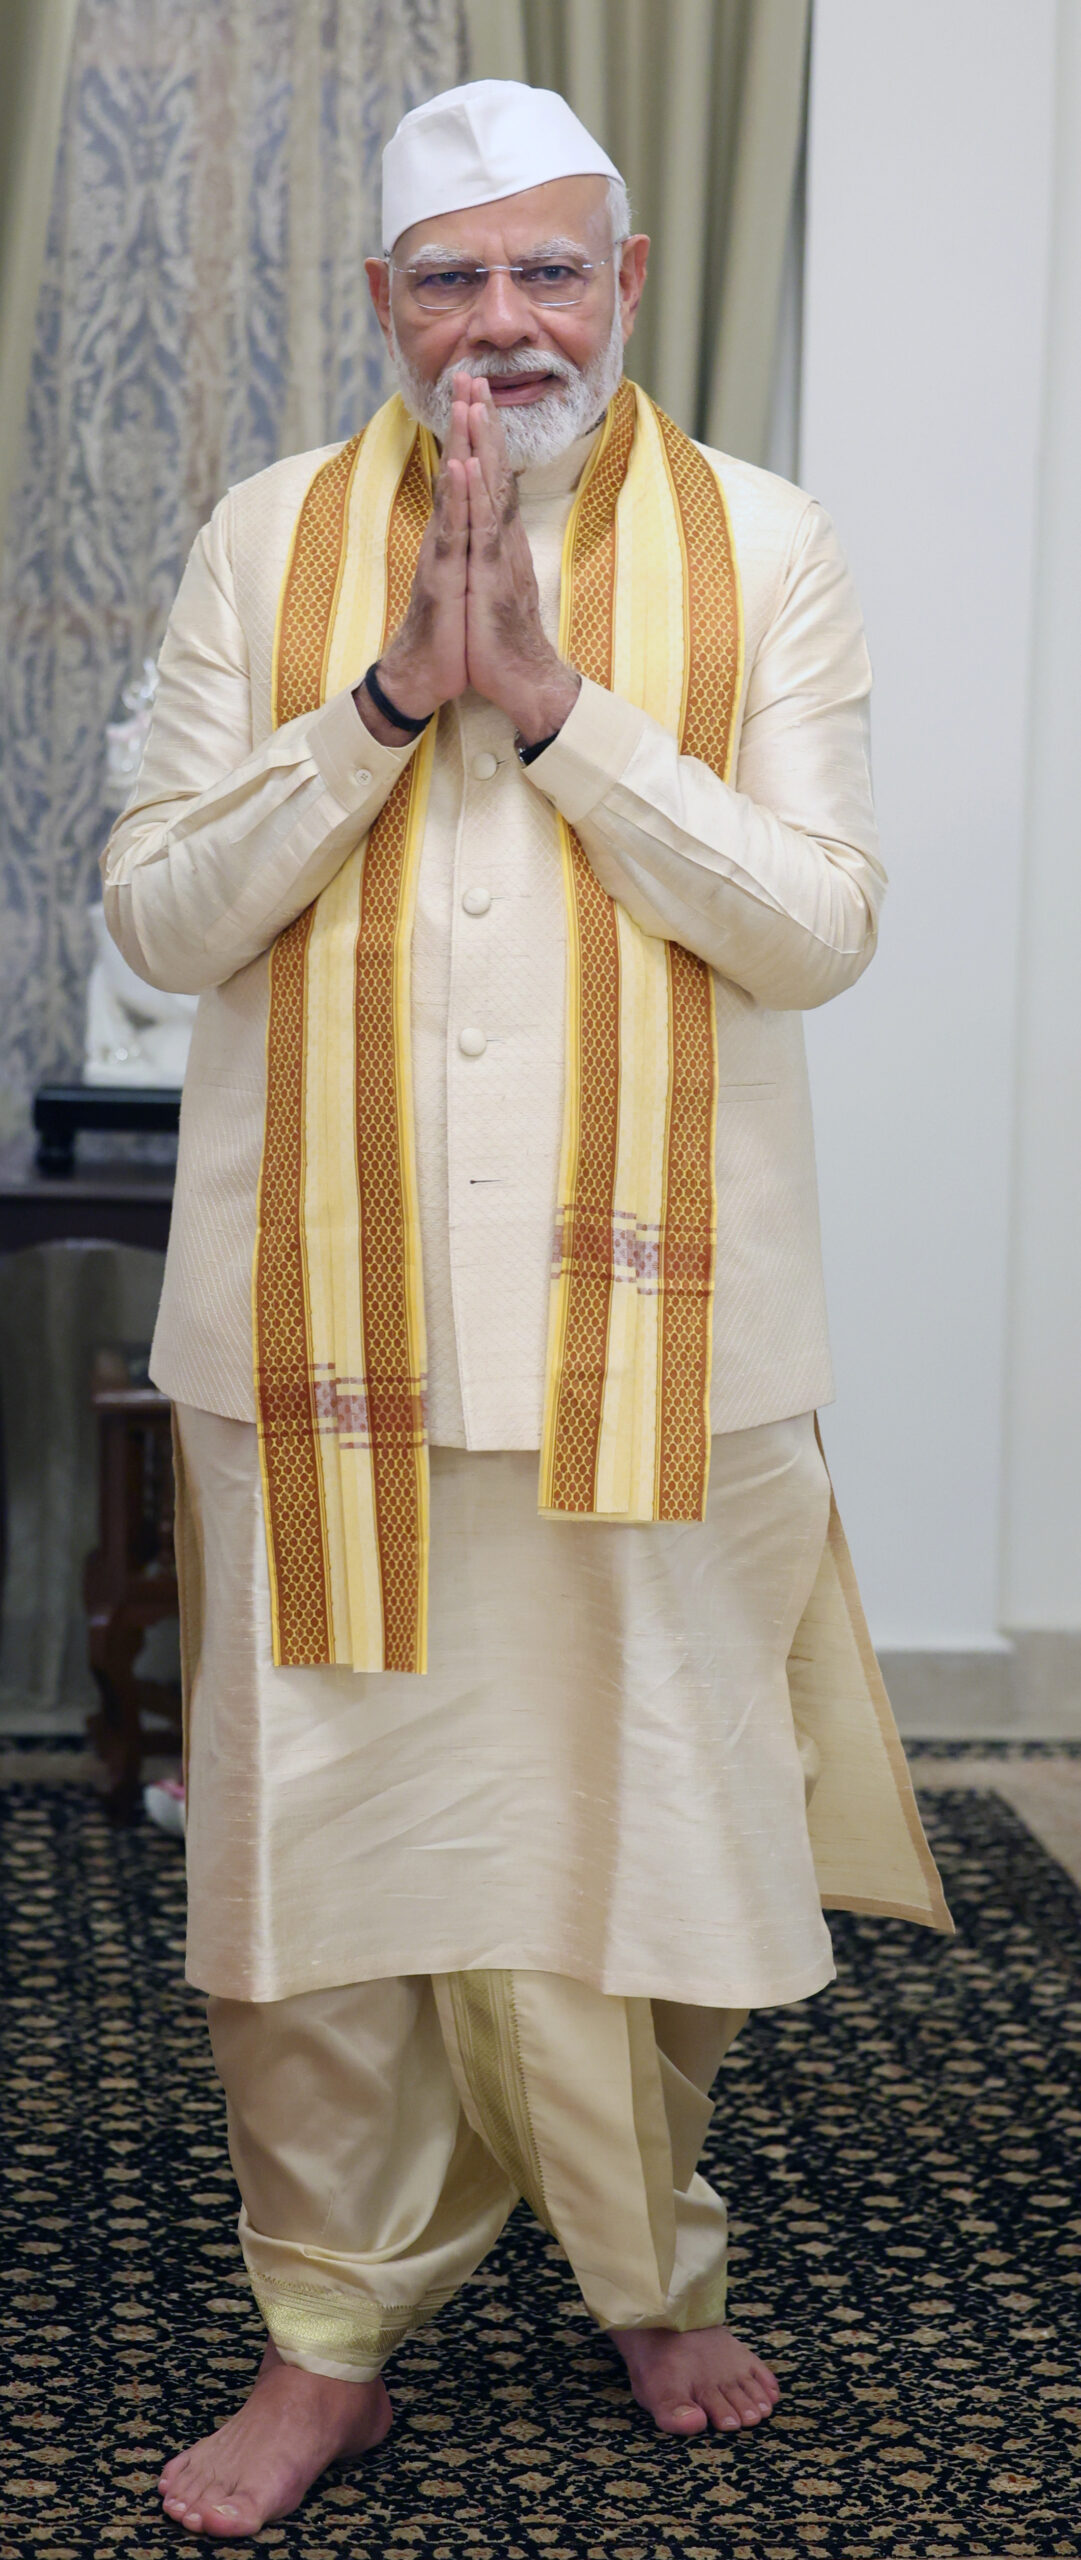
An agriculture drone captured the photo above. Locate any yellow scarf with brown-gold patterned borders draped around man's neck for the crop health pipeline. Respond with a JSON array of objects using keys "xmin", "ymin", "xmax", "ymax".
[{"xmin": 254, "ymin": 381, "xmax": 743, "ymax": 1672}]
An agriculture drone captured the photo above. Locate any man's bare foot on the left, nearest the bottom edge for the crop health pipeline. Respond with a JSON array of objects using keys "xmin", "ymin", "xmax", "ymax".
[{"xmin": 159, "ymin": 2345, "xmax": 392, "ymax": 2542}]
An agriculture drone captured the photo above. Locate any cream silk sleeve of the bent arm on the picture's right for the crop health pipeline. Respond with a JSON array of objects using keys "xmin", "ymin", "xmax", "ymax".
[{"xmin": 528, "ymin": 499, "xmax": 886, "ymax": 1011}]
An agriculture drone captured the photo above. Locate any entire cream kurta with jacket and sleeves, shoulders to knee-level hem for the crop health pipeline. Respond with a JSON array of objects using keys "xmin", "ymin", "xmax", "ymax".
[{"xmin": 105, "ymin": 409, "xmax": 945, "ymax": 2007}]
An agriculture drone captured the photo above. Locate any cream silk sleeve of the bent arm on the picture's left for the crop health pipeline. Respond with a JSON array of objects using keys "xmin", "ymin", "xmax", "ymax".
[{"xmin": 102, "ymin": 483, "xmax": 412, "ymax": 993}]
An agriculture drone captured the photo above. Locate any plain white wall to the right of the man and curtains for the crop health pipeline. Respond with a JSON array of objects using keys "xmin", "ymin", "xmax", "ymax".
[{"xmin": 799, "ymin": 0, "xmax": 1060, "ymax": 1651}]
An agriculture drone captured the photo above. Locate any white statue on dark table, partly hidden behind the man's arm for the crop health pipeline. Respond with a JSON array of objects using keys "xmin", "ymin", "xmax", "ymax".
[{"xmin": 82, "ymin": 658, "xmax": 200, "ymax": 1085}]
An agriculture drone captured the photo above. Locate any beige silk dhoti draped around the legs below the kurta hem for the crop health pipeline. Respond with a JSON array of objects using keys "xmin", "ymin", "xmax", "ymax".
[{"xmin": 207, "ymin": 1971, "xmax": 743, "ymax": 2381}]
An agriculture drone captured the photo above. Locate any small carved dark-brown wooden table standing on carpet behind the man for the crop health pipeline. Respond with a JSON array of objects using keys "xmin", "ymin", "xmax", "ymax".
[{"xmin": 85, "ymin": 1370, "xmax": 179, "ymax": 1823}]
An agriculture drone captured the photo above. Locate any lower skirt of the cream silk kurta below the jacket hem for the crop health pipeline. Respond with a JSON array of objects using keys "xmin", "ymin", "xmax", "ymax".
[{"xmin": 177, "ymin": 1405, "xmax": 833, "ymax": 2010}]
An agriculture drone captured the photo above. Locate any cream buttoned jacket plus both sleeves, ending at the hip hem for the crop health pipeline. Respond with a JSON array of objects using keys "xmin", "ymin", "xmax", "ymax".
[{"xmin": 102, "ymin": 401, "xmax": 884, "ymax": 1449}]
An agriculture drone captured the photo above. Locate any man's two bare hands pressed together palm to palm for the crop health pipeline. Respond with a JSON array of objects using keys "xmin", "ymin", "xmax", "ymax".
[{"xmin": 356, "ymin": 371, "xmax": 581, "ymax": 748}]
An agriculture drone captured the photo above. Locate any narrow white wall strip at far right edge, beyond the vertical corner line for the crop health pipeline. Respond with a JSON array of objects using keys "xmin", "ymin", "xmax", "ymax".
[{"xmin": 1002, "ymin": 0, "xmax": 1081, "ymax": 1628}]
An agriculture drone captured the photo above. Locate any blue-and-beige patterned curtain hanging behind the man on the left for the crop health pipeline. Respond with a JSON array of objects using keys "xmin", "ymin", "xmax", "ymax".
[{"xmin": 0, "ymin": 0, "xmax": 466, "ymax": 1139}]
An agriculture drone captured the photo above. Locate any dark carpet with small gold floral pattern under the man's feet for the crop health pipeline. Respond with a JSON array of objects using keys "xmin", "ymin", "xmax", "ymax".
[{"xmin": 0, "ymin": 1769, "xmax": 1081, "ymax": 2560}]
